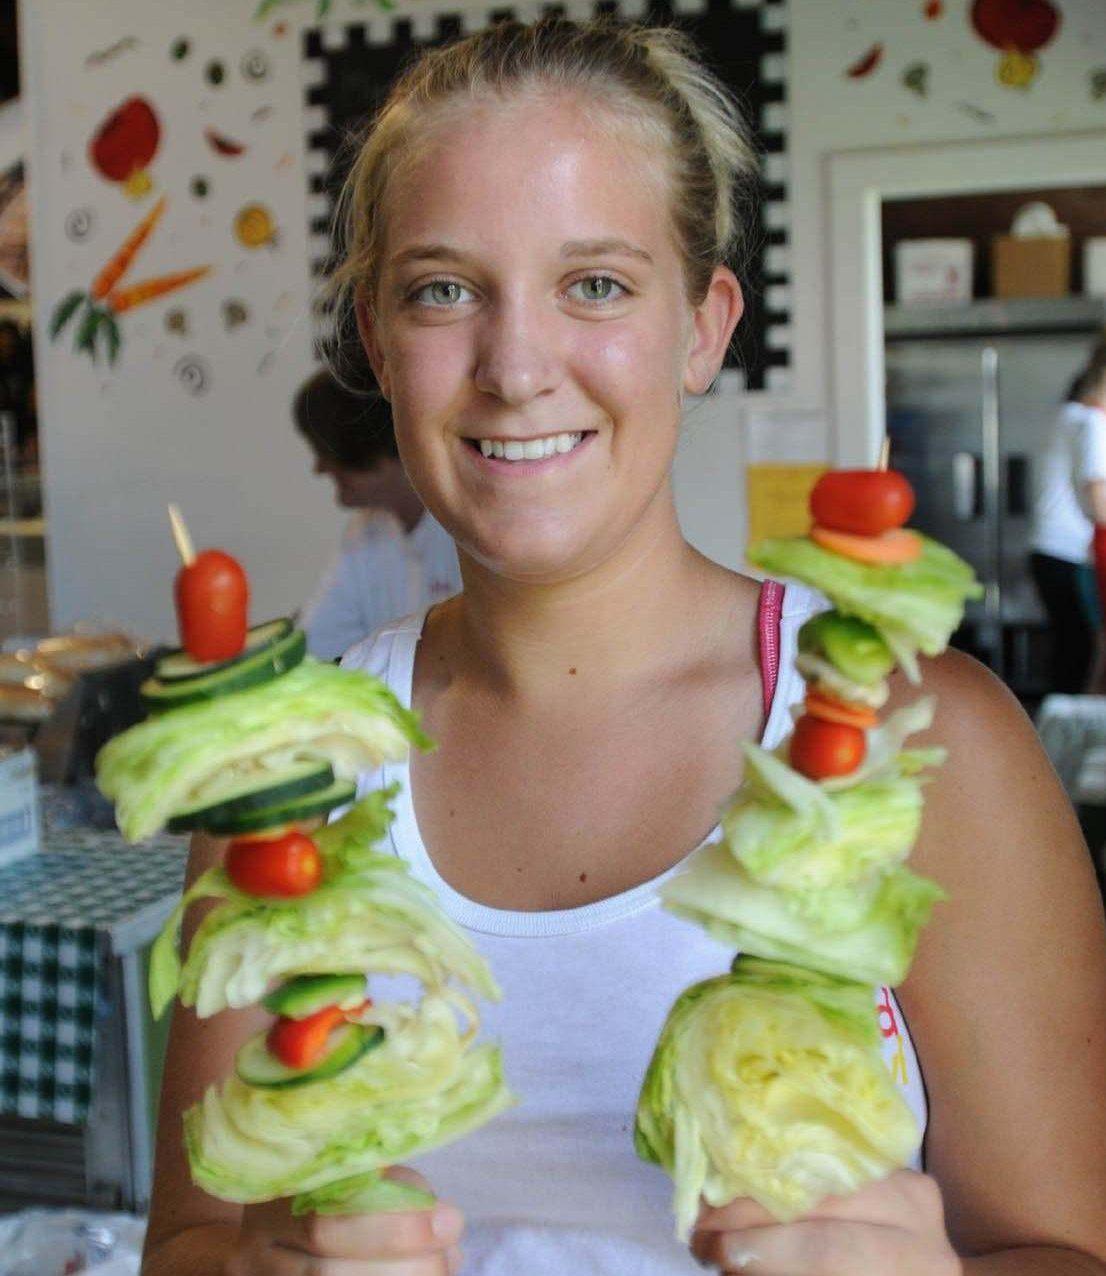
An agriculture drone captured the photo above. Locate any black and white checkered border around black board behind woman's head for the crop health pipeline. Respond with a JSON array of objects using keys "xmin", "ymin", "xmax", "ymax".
[{"xmin": 300, "ymin": 0, "xmax": 792, "ymax": 392}]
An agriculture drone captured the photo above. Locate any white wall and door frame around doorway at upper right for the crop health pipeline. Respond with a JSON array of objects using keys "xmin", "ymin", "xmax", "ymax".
[{"xmin": 790, "ymin": 0, "xmax": 1106, "ymax": 441}]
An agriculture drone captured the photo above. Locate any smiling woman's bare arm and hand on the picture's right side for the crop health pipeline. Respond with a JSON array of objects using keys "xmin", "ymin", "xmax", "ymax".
[{"xmin": 693, "ymin": 652, "xmax": 1106, "ymax": 1276}]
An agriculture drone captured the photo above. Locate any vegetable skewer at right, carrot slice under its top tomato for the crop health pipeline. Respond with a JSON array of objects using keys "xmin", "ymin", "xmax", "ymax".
[{"xmin": 635, "ymin": 446, "xmax": 980, "ymax": 1238}]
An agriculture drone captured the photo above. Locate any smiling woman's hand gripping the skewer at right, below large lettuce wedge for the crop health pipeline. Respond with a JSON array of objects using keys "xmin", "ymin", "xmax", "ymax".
[{"xmin": 691, "ymin": 1170, "xmax": 963, "ymax": 1276}]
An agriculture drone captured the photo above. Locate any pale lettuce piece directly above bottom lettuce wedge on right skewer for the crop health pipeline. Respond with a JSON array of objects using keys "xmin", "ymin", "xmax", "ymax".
[{"xmin": 661, "ymin": 842, "xmax": 944, "ymax": 984}]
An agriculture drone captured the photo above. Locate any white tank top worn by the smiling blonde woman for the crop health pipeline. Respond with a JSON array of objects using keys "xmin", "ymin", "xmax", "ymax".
[{"xmin": 343, "ymin": 586, "xmax": 926, "ymax": 1276}]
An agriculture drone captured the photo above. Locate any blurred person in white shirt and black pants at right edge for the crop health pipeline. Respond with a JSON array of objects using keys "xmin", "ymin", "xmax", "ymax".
[{"xmin": 1029, "ymin": 341, "xmax": 1106, "ymax": 693}]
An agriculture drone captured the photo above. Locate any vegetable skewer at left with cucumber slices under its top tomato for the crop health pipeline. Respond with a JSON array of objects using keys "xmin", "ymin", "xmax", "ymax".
[{"xmin": 97, "ymin": 518, "xmax": 513, "ymax": 1213}]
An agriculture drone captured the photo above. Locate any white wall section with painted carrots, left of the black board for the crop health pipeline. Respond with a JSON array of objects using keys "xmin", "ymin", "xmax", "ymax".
[{"xmin": 23, "ymin": 0, "xmax": 341, "ymax": 638}]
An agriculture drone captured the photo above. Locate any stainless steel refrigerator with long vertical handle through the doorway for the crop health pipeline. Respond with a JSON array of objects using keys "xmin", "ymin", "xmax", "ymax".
[{"xmin": 884, "ymin": 297, "xmax": 1106, "ymax": 701}]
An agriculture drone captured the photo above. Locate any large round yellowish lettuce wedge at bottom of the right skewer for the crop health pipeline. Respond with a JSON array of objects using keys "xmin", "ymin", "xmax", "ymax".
[{"xmin": 634, "ymin": 957, "xmax": 920, "ymax": 1239}]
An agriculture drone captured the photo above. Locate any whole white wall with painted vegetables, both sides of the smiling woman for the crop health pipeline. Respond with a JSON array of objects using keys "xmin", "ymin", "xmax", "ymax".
[{"xmin": 23, "ymin": 0, "xmax": 1106, "ymax": 637}]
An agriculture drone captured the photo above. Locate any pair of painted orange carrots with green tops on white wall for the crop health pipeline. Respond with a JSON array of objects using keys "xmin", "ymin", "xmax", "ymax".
[{"xmin": 50, "ymin": 195, "xmax": 212, "ymax": 364}]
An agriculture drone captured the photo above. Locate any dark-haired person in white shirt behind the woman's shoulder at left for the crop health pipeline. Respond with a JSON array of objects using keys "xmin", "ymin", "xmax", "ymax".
[{"xmin": 292, "ymin": 369, "xmax": 461, "ymax": 660}]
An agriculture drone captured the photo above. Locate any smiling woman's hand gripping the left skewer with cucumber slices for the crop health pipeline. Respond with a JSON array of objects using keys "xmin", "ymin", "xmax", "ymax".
[{"xmin": 223, "ymin": 1168, "xmax": 464, "ymax": 1276}]
